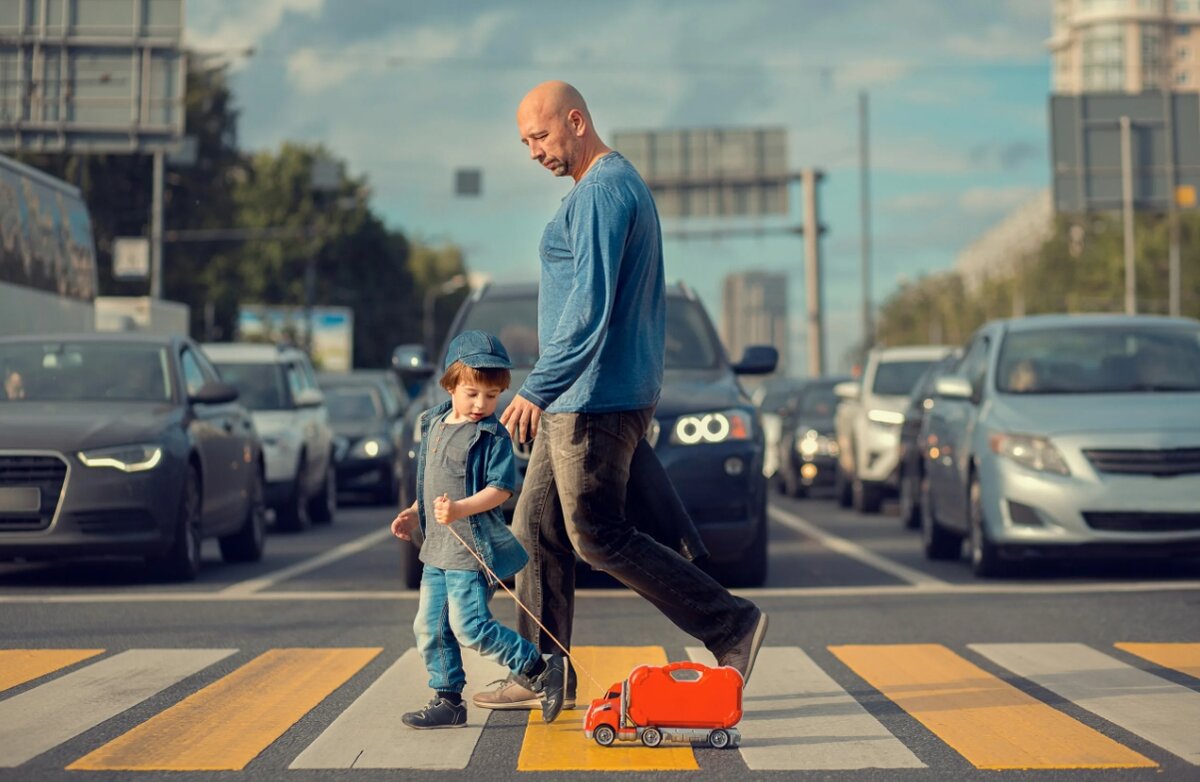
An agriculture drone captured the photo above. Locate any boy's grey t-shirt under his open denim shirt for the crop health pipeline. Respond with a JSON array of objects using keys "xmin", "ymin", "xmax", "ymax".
[{"xmin": 421, "ymin": 410, "xmax": 480, "ymax": 570}]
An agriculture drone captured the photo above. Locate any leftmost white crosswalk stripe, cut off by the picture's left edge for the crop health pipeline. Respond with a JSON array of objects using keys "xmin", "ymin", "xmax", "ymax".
[{"xmin": 0, "ymin": 649, "xmax": 235, "ymax": 768}]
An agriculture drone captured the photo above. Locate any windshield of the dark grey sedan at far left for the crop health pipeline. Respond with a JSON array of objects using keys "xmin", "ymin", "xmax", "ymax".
[{"xmin": 0, "ymin": 342, "xmax": 170, "ymax": 402}]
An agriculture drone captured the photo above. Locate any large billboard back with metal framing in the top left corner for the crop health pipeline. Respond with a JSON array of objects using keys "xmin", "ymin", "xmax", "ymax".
[{"xmin": 0, "ymin": 0, "xmax": 186, "ymax": 152}]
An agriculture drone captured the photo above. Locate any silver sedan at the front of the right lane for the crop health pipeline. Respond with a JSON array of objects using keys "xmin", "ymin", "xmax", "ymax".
[{"xmin": 920, "ymin": 315, "xmax": 1200, "ymax": 576}]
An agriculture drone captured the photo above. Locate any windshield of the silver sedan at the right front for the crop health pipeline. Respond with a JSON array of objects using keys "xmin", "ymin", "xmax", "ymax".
[{"xmin": 996, "ymin": 323, "xmax": 1200, "ymax": 393}]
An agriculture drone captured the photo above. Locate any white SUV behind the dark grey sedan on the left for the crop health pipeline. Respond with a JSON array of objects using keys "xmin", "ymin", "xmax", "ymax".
[{"xmin": 203, "ymin": 342, "xmax": 337, "ymax": 531}]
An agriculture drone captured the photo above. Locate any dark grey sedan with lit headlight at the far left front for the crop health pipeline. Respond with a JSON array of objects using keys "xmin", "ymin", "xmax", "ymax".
[{"xmin": 0, "ymin": 333, "xmax": 265, "ymax": 581}]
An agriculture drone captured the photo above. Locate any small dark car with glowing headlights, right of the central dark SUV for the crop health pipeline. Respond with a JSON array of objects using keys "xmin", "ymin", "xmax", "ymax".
[{"xmin": 779, "ymin": 375, "xmax": 851, "ymax": 497}]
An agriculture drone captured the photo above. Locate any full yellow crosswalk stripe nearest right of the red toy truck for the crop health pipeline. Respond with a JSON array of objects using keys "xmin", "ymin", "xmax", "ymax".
[{"xmin": 829, "ymin": 644, "xmax": 1156, "ymax": 769}]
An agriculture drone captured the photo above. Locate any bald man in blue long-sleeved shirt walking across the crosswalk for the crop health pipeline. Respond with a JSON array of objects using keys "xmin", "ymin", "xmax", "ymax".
[{"xmin": 474, "ymin": 82, "xmax": 767, "ymax": 709}]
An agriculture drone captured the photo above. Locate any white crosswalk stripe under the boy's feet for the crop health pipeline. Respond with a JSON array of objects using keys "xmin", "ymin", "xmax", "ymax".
[{"xmin": 289, "ymin": 649, "xmax": 509, "ymax": 770}]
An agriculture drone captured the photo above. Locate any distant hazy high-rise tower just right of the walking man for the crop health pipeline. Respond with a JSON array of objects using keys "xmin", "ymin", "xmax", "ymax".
[{"xmin": 721, "ymin": 271, "xmax": 788, "ymax": 374}]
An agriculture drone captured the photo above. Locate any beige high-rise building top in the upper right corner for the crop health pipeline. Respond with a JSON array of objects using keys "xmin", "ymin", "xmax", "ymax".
[{"xmin": 1046, "ymin": 0, "xmax": 1200, "ymax": 95}]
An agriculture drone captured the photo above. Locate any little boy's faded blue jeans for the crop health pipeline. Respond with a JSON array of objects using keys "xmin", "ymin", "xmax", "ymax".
[{"xmin": 413, "ymin": 565, "xmax": 541, "ymax": 693}]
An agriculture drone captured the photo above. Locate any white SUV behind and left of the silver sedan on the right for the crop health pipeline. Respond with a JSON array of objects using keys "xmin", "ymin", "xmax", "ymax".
[{"xmin": 834, "ymin": 345, "xmax": 950, "ymax": 513}]
